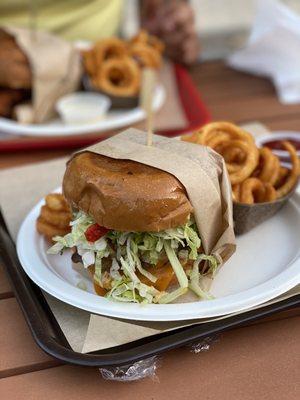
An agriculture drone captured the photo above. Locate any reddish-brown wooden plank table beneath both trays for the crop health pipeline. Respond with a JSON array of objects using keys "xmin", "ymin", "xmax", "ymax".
[{"xmin": 0, "ymin": 62, "xmax": 300, "ymax": 400}]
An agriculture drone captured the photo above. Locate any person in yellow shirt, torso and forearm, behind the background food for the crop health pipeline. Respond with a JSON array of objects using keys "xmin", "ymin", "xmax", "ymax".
[{"xmin": 0, "ymin": 0, "xmax": 198, "ymax": 64}]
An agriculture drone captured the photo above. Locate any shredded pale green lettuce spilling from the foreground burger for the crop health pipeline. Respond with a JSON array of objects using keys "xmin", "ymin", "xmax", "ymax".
[{"xmin": 48, "ymin": 211, "xmax": 218, "ymax": 304}]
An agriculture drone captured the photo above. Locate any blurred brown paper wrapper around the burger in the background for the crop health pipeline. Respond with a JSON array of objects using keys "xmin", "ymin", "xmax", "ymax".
[{"xmin": 3, "ymin": 27, "xmax": 81, "ymax": 123}]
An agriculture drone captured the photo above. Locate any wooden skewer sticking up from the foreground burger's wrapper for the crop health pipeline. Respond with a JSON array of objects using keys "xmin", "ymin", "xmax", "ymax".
[{"xmin": 140, "ymin": 68, "xmax": 156, "ymax": 146}]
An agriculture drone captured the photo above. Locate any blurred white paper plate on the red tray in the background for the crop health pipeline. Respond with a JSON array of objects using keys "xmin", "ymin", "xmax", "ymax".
[{"xmin": 0, "ymin": 85, "xmax": 166, "ymax": 137}]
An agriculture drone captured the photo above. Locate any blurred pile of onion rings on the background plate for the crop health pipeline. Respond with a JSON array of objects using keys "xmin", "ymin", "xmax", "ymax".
[{"xmin": 82, "ymin": 30, "xmax": 164, "ymax": 97}]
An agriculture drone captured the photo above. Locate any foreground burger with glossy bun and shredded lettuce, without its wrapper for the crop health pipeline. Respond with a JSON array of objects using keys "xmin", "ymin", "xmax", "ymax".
[{"xmin": 48, "ymin": 152, "xmax": 218, "ymax": 303}]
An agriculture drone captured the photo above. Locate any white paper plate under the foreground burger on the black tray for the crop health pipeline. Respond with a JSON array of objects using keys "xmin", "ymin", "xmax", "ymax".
[{"xmin": 17, "ymin": 194, "xmax": 300, "ymax": 321}]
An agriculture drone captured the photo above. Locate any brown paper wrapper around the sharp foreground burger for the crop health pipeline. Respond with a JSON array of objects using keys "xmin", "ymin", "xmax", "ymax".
[{"xmin": 72, "ymin": 128, "xmax": 235, "ymax": 264}]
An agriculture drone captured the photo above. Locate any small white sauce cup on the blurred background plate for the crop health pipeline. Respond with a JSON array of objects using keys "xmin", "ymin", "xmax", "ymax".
[{"xmin": 56, "ymin": 92, "xmax": 111, "ymax": 125}]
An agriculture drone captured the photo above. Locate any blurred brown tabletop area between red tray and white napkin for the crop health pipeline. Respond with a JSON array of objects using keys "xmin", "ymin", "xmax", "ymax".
[{"xmin": 191, "ymin": 62, "xmax": 300, "ymax": 122}]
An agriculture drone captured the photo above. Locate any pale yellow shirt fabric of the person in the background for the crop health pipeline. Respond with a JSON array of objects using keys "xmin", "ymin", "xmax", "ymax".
[{"xmin": 0, "ymin": 0, "xmax": 122, "ymax": 41}]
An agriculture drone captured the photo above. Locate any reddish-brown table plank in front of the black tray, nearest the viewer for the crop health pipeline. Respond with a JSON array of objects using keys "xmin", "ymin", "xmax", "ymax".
[{"xmin": 0, "ymin": 318, "xmax": 300, "ymax": 400}]
